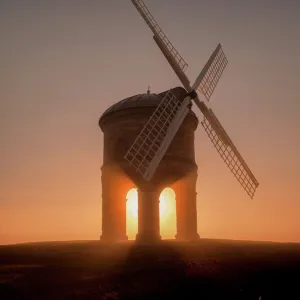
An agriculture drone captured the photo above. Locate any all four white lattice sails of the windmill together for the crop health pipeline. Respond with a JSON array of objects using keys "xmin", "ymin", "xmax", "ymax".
[{"xmin": 124, "ymin": 0, "xmax": 259, "ymax": 198}]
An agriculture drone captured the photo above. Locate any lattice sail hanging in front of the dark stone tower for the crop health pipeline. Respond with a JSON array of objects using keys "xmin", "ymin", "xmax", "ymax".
[{"xmin": 124, "ymin": 90, "xmax": 190, "ymax": 180}]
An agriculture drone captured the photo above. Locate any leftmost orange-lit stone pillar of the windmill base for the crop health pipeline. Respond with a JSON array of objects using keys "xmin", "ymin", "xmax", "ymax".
[{"xmin": 100, "ymin": 165, "xmax": 128, "ymax": 243}]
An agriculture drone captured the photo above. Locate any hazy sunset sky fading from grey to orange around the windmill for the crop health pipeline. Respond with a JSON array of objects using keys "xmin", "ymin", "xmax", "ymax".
[{"xmin": 0, "ymin": 0, "xmax": 300, "ymax": 244}]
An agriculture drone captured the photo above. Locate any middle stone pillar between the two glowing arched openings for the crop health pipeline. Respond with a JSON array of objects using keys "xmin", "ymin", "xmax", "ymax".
[{"xmin": 136, "ymin": 186, "xmax": 161, "ymax": 243}]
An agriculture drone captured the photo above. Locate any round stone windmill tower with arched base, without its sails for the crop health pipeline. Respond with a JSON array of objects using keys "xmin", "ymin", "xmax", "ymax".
[{"xmin": 99, "ymin": 88, "xmax": 198, "ymax": 242}]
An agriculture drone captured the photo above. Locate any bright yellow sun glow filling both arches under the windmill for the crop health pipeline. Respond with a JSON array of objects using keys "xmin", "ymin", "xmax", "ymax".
[{"xmin": 126, "ymin": 188, "xmax": 176, "ymax": 239}]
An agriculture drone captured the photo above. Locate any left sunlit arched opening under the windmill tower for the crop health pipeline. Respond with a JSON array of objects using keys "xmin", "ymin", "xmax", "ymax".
[{"xmin": 126, "ymin": 188, "xmax": 138, "ymax": 240}]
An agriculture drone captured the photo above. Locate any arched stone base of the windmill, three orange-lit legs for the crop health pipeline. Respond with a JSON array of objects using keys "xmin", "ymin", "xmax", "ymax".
[{"xmin": 101, "ymin": 164, "xmax": 199, "ymax": 242}]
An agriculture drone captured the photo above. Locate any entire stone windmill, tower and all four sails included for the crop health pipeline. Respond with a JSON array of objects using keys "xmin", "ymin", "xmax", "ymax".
[{"xmin": 99, "ymin": 0, "xmax": 259, "ymax": 242}]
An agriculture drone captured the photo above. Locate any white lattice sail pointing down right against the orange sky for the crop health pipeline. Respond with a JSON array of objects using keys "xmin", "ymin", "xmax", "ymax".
[{"xmin": 201, "ymin": 109, "xmax": 259, "ymax": 198}]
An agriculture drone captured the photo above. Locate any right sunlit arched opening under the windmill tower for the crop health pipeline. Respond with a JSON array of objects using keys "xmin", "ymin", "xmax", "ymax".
[{"xmin": 159, "ymin": 188, "xmax": 177, "ymax": 239}]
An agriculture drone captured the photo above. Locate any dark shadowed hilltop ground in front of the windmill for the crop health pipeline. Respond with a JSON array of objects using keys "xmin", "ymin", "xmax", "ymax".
[{"xmin": 0, "ymin": 240, "xmax": 300, "ymax": 300}]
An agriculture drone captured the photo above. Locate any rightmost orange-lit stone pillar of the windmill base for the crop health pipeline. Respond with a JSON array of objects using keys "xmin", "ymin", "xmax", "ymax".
[{"xmin": 172, "ymin": 171, "xmax": 199, "ymax": 241}]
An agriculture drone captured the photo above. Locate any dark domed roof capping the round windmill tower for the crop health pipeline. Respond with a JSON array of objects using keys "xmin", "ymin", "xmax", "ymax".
[{"xmin": 99, "ymin": 87, "xmax": 196, "ymax": 122}]
